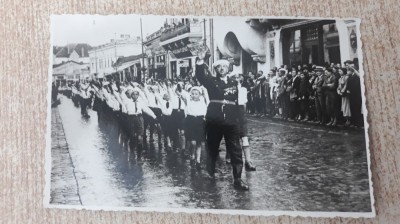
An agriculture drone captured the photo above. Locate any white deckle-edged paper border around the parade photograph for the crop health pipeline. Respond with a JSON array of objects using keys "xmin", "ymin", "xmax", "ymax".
[{"xmin": 43, "ymin": 14, "xmax": 376, "ymax": 218}]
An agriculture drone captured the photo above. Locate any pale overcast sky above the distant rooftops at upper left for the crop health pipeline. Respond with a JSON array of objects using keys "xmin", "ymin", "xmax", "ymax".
[{"xmin": 51, "ymin": 15, "xmax": 166, "ymax": 46}]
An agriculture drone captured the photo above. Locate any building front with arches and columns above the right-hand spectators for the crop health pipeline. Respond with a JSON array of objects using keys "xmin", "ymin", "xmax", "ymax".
[{"xmin": 215, "ymin": 17, "xmax": 361, "ymax": 74}]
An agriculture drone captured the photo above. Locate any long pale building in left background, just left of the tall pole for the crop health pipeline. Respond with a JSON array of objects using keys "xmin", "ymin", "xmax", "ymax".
[{"xmin": 89, "ymin": 35, "xmax": 142, "ymax": 78}]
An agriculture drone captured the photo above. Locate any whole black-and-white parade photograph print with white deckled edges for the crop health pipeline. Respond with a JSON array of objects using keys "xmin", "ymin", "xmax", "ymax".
[{"xmin": 44, "ymin": 15, "xmax": 375, "ymax": 217}]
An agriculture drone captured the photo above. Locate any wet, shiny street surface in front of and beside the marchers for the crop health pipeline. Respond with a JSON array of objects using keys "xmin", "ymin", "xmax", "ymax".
[{"xmin": 54, "ymin": 97, "xmax": 371, "ymax": 212}]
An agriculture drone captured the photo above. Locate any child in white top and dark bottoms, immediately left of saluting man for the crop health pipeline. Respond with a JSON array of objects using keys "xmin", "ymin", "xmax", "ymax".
[{"xmin": 185, "ymin": 86, "xmax": 208, "ymax": 170}]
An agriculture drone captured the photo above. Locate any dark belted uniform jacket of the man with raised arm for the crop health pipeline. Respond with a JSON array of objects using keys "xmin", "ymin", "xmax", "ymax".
[{"xmin": 195, "ymin": 64, "xmax": 240, "ymax": 123}]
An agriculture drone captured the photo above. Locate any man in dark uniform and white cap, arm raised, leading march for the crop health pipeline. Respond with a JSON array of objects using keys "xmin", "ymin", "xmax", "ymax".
[{"xmin": 195, "ymin": 47, "xmax": 249, "ymax": 190}]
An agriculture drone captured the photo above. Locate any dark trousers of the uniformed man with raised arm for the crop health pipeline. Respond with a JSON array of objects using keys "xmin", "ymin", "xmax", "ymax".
[{"xmin": 206, "ymin": 121, "xmax": 243, "ymax": 179}]
